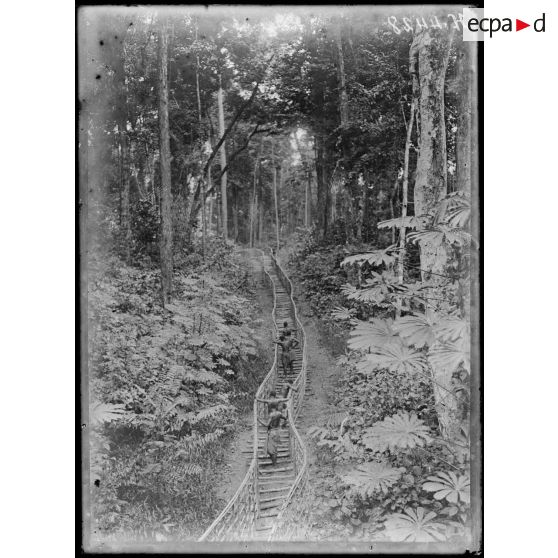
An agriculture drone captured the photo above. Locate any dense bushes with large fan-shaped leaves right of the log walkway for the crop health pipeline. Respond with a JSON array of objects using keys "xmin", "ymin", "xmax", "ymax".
[{"xmin": 289, "ymin": 221, "xmax": 470, "ymax": 542}]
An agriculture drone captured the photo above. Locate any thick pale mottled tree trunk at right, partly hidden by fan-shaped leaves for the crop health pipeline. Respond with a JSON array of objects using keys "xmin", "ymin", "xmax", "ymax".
[{"xmin": 411, "ymin": 29, "xmax": 459, "ymax": 437}]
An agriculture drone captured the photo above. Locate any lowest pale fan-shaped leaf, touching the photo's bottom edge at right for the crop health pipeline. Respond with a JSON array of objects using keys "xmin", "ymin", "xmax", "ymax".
[{"xmin": 385, "ymin": 507, "xmax": 445, "ymax": 542}]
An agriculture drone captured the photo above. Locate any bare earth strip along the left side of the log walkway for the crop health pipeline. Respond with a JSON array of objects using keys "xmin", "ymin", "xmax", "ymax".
[{"xmin": 215, "ymin": 258, "xmax": 275, "ymax": 508}]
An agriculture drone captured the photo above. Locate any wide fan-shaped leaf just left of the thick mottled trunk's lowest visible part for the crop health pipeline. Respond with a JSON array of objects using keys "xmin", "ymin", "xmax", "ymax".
[{"xmin": 362, "ymin": 413, "xmax": 432, "ymax": 451}]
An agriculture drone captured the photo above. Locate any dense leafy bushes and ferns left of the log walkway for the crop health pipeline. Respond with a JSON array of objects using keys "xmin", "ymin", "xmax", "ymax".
[{"xmin": 88, "ymin": 245, "xmax": 267, "ymax": 541}]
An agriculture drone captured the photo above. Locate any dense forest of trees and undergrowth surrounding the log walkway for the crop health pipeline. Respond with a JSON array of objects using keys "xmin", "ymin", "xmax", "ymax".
[{"xmin": 78, "ymin": 6, "xmax": 480, "ymax": 548}]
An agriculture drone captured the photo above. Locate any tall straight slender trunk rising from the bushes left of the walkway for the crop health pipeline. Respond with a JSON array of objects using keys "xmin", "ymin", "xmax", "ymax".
[{"xmin": 158, "ymin": 22, "xmax": 173, "ymax": 305}]
